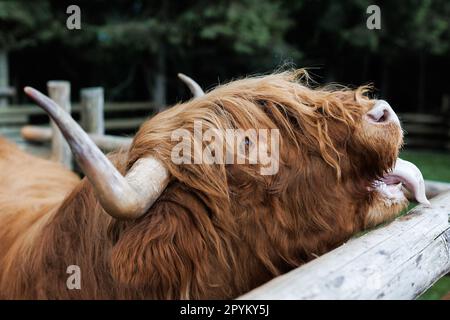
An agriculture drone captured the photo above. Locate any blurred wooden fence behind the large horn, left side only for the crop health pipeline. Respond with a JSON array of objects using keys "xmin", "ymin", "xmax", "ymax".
[{"xmin": 0, "ymin": 81, "xmax": 159, "ymax": 160}]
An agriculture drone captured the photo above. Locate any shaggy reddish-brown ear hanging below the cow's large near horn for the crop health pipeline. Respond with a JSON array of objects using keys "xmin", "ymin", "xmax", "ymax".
[{"xmin": 111, "ymin": 202, "xmax": 212, "ymax": 299}]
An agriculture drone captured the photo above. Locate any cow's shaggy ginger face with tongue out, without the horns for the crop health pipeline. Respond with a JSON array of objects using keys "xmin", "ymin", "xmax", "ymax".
[{"xmin": 133, "ymin": 72, "xmax": 428, "ymax": 233}]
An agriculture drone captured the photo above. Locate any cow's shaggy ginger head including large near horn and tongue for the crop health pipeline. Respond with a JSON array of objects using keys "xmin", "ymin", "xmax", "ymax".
[{"xmin": 26, "ymin": 72, "xmax": 427, "ymax": 263}]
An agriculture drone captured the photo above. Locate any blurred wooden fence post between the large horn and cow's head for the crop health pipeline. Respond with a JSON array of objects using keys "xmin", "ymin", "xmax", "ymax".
[{"xmin": 80, "ymin": 87, "xmax": 105, "ymax": 135}]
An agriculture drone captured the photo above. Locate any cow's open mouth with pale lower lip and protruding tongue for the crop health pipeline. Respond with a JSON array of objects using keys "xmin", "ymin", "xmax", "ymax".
[{"xmin": 373, "ymin": 158, "xmax": 430, "ymax": 205}]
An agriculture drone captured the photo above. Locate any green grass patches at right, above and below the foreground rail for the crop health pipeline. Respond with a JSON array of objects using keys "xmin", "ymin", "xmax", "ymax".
[{"xmin": 400, "ymin": 150, "xmax": 450, "ymax": 300}]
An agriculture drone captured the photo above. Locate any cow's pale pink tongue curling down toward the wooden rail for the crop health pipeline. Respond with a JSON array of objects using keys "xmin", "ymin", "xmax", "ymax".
[{"xmin": 383, "ymin": 158, "xmax": 430, "ymax": 205}]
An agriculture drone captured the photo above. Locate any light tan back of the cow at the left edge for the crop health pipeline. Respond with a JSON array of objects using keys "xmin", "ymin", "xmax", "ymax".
[{"xmin": 0, "ymin": 137, "xmax": 79, "ymax": 296}]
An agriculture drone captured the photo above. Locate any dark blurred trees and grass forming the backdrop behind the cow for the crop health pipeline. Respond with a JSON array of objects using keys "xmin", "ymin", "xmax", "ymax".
[{"xmin": 0, "ymin": 0, "xmax": 450, "ymax": 298}]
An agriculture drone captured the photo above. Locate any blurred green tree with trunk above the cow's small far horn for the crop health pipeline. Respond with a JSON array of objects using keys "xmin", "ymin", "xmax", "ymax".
[{"xmin": 49, "ymin": 0, "xmax": 298, "ymax": 105}]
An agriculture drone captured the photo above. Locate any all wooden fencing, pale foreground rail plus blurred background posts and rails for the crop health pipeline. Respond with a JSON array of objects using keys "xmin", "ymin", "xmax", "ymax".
[{"xmin": 0, "ymin": 82, "xmax": 450, "ymax": 299}]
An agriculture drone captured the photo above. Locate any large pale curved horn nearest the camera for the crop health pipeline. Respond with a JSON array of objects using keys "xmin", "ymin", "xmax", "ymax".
[{"xmin": 24, "ymin": 87, "xmax": 169, "ymax": 219}]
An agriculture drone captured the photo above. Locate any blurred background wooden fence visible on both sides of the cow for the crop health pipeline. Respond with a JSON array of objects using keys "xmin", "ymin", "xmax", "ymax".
[{"xmin": 0, "ymin": 81, "xmax": 450, "ymax": 159}]
